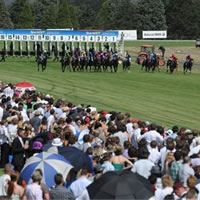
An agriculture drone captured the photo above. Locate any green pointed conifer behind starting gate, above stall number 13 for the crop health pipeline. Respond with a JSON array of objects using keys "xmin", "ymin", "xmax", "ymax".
[{"xmin": 17, "ymin": 0, "xmax": 34, "ymax": 29}]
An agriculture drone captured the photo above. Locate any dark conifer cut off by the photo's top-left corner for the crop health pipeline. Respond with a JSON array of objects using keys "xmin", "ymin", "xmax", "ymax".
[{"xmin": 0, "ymin": 0, "xmax": 13, "ymax": 29}]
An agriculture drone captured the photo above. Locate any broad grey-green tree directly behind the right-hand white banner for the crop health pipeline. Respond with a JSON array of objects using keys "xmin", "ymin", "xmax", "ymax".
[{"xmin": 136, "ymin": 0, "xmax": 167, "ymax": 36}]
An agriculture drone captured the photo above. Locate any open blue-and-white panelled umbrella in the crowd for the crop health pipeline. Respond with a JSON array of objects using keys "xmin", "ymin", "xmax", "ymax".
[{"xmin": 21, "ymin": 152, "xmax": 73, "ymax": 188}]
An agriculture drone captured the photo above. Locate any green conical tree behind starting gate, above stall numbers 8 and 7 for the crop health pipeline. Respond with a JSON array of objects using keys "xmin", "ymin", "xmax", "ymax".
[{"xmin": 57, "ymin": 0, "xmax": 72, "ymax": 28}]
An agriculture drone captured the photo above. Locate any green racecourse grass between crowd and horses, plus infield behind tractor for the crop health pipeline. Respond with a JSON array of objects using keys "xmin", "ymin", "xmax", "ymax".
[{"xmin": 0, "ymin": 41, "xmax": 200, "ymax": 129}]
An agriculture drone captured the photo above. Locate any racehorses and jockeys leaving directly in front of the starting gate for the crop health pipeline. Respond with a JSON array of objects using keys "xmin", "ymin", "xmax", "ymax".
[{"xmin": 36, "ymin": 53, "xmax": 131, "ymax": 72}]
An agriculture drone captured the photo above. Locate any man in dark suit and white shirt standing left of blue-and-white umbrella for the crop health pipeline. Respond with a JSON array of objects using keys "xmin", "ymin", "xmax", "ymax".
[{"xmin": 12, "ymin": 128, "xmax": 29, "ymax": 172}]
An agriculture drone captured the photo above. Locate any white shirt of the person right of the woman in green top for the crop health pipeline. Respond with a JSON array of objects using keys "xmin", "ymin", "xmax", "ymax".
[{"xmin": 131, "ymin": 159, "xmax": 155, "ymax": 179}]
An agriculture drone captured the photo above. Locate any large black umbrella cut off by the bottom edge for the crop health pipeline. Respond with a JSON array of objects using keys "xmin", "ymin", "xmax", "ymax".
[{"xmin": 87, "ymin": 170, "xmax": 153, "ymax": 199}]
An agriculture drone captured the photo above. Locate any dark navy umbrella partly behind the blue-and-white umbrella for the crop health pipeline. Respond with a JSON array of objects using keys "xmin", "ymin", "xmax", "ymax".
[{"xmin": 58, "ymin": 146, "xmax": 92, "ymax": 172}]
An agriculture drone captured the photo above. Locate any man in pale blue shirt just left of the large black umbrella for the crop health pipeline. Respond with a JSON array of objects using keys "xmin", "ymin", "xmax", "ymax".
[{"xmin": 70, "ymin": 169, "xmax": 92, "ymax": 198}]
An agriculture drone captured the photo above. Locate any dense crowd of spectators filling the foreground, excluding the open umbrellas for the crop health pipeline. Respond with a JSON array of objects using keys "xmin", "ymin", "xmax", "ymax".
[{"xmin": 0, "ymin": 83, "xmax": 200, "ymax": 200}]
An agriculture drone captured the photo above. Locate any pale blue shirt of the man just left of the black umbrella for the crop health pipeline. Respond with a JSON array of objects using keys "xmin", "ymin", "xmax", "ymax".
[{"xmin": 70, "ymin": 177, "xmax": 92, "ymax": 198}]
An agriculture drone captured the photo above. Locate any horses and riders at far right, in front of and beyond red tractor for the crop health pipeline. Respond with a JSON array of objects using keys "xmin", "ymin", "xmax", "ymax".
[{"xmin": 142, "ymin": 57, "xmax": 194, "ymax": 74}]
